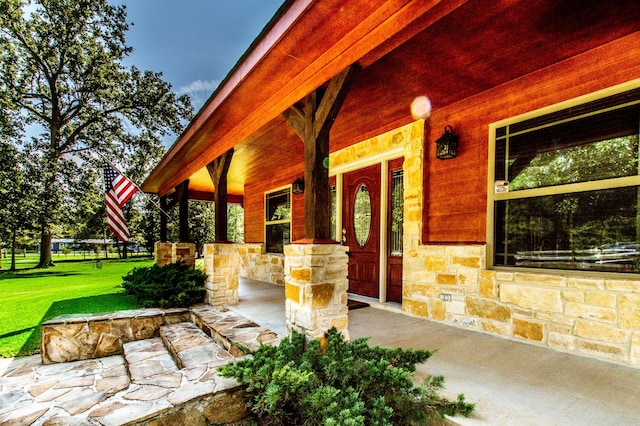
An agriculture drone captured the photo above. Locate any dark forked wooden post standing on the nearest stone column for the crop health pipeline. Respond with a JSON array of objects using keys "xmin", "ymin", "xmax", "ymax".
[{"xmin": 283, "ymin": 64, "xmax": 359, "ymax": 241}]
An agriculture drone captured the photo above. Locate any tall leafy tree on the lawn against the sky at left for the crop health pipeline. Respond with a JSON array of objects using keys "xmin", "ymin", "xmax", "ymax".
[{"xmin": 0, "ymin": 0, "xmax": 192, "ymax": 266}]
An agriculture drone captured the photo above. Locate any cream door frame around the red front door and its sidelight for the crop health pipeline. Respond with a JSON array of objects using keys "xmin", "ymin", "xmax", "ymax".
[{"xmin": 329, "ymin": 146, "xmax": 404, "ymax": 303}]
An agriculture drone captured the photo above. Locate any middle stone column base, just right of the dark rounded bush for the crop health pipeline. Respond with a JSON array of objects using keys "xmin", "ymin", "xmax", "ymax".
[{"xmin": 204, "ymin": 243, "xmax": 240, "ymax": 305}]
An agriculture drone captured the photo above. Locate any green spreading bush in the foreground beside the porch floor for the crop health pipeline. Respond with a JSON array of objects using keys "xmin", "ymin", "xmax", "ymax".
[{"xmin": 220, "ymin": 329, "xmax": 474, "ymax": 426}]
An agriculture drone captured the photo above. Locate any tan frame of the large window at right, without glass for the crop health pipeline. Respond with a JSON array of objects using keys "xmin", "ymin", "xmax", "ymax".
[{"xmin": 486, "ymin": 79, "xmax": 640, "ymax": 279}]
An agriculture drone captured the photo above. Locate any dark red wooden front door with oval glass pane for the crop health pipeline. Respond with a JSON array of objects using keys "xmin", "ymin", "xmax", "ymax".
[{"xmin": 342, "ymin": 164, "xmax": 380, "ymax": 298}]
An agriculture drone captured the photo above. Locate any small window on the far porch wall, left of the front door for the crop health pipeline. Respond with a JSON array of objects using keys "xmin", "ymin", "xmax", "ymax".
[{"xmin": 264, "ymin": 188, "xmax": 291, "ymax": 253}]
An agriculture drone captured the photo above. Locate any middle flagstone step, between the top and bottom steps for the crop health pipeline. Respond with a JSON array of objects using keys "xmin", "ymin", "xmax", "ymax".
[{"xmin": 160, "ymin": 322, "xmax": 234, "ymax": 369}]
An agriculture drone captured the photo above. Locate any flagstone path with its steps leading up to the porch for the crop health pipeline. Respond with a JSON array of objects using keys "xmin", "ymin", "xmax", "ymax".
[{"xmin": 0, "ymin": 305, "xmax": 280, "ymax": 426}]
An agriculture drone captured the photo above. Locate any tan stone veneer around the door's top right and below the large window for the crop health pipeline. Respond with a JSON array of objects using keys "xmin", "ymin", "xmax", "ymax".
[{"xmin": 330, "ymin": 120, "xmax": 640, "ymax": 367}]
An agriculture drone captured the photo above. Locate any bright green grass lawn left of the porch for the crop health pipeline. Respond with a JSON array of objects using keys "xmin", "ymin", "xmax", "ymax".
[{"xmin": 0, "ymin": 255, "xmax": 153, "ymax": 357}]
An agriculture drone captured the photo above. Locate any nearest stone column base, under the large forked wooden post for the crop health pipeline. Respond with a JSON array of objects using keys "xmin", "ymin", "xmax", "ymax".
[{"xmin": 284, "ymin": 244, "xmax": 349, "ymax": 340}]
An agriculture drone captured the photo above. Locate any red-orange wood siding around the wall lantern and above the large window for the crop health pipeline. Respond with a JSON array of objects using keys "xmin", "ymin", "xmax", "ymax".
[{"xmin": 423, "ymin": 33, "xmax": 640, "ymax": 243}]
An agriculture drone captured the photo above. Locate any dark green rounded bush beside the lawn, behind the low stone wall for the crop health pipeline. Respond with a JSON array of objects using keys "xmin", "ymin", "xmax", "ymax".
[{"xmin": 122, "ymin": 262, "xmax": 207, "ymax": 308}]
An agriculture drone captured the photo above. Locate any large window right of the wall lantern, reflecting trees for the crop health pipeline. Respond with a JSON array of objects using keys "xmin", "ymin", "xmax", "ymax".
[{"xmin": 490, "ymin": 85, "xmax": 640, "ymax": 273}]
